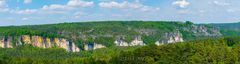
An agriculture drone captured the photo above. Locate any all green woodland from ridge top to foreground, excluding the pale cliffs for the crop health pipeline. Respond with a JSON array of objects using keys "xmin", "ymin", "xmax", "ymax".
[{"xmin": 0, "ymin": 21, "xmax": 240, "ymax": 64}]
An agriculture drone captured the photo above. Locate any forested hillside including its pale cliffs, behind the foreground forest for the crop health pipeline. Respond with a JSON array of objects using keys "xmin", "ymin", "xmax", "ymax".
[{"xmin": 0, "ymin": 21, "xmax": 222, "ymax": 50}]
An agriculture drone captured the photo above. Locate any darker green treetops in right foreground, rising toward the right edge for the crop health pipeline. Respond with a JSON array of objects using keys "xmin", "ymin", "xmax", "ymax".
[{"xmin": 111, "ymin": 37, "xmax": 240, "ymax": 64}]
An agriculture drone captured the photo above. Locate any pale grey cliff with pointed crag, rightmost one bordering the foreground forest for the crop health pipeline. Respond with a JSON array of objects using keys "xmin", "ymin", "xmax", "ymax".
[{"xmin": 155, "ymin": 31, "xmax": 183, "ymax": 45}]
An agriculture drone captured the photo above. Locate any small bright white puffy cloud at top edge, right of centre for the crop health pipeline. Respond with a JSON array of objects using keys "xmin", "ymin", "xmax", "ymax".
[{"xmin": 172, "ymin": 0, "xmax": 190, "ymax": 8}]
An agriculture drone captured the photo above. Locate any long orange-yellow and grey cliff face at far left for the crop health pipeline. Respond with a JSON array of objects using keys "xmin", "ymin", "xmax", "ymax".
[{"xmin": 0, "ymin": 35, "xmax": 80, "ymax": 52}]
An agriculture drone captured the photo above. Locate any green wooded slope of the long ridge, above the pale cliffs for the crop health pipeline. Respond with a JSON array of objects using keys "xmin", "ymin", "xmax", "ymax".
[{"xmin": 0, "ymin": 21, "xmax": 221, "ymax": 47}]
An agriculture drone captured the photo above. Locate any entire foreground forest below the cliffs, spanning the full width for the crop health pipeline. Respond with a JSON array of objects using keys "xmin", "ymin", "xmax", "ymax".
[{"xmin": 0, "ymin": 37, "xmax": 240, "ymax": 64}]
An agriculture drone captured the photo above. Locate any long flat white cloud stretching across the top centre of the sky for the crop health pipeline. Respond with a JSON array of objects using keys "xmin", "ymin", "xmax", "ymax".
[{"xmin": 98, "ymin": 1, "xmax": 159, "ymax": 11}]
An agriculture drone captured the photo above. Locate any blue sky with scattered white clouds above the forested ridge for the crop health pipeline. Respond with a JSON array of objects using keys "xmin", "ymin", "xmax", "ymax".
[{"xmin": 0, "ymin": 0, "xmax": 240, "ymax": 26}]
